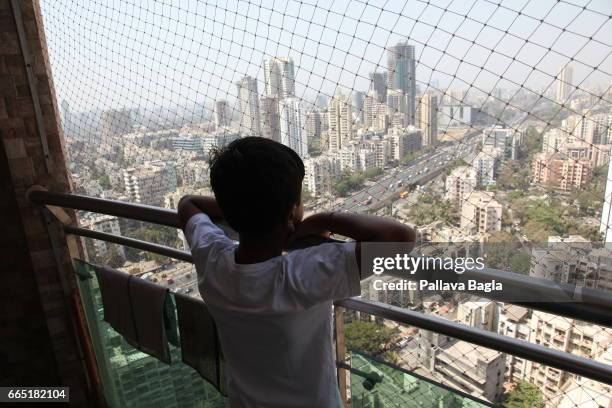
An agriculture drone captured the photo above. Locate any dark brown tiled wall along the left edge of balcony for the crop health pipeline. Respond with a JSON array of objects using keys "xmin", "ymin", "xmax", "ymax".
[{"xmin": 0, "ymin": 0, "xmax": 93, "ymax": 406}]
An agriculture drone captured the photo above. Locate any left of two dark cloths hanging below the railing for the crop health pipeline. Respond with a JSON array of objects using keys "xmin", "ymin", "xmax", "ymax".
[{"xmin": 94, "ymin": 266, "xmax": 171, "ymax": 364}]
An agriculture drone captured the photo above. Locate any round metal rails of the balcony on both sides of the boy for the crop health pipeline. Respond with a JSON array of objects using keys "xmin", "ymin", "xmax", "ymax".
[{"xmin": 28, "ymin": 189, "xmax": 612, "ymax": 384}]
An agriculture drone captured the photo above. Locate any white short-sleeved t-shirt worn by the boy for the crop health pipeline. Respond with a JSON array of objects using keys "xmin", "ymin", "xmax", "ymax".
[{"xmin": 185, "ymin": 214, "xmax": 360, "ymax": 408}]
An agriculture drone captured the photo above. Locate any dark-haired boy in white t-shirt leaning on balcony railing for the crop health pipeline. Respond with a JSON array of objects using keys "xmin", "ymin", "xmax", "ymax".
[{"xmin": 178, "ymin": 137, "xmax": 414, "ymax": 408}]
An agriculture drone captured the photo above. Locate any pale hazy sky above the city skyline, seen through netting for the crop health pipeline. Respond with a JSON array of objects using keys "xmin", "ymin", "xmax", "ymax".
[{"xmin": 41, "ymin": 0, "xmax": 612, "ymax": 111}]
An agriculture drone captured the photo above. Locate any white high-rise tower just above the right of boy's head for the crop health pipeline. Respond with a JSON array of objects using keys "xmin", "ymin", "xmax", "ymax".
[{"xmin": 279, "ymin": 98, "xmax": 308, "ymax": 158}]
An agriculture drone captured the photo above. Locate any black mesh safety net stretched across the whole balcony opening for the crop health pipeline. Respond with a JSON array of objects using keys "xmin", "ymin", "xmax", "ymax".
[{"xmin": 41, "ymin": 0, "xmax": 612, "ymax": 407}]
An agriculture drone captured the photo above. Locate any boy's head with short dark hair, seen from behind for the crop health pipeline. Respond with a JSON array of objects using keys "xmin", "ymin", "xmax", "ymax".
[{"xmin": 210, "ymin": 137, "xmax": 304, "ymax": 235}]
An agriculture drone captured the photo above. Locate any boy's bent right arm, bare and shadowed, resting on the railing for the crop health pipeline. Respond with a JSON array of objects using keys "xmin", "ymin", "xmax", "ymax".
[{"xmin": 292, "ymin": 212, "xmax": 416, "ymax": 279}]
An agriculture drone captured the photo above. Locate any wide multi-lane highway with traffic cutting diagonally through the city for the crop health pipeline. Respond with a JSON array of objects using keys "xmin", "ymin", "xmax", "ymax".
[{"xmin": 334, "ymin": 130, "xmax": 482, "ymax": 212}]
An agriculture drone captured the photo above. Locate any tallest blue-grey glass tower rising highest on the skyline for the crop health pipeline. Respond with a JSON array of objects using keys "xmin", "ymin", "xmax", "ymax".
[{"xmin": 387, "ymin": 42, "xmax": 416, "ymax": 125}]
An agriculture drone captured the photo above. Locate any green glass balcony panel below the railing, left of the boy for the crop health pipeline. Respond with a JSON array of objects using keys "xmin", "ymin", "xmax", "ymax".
[{"xmin": 74, "ymin": 260, "xmax": 227, "ymax": 408}]
